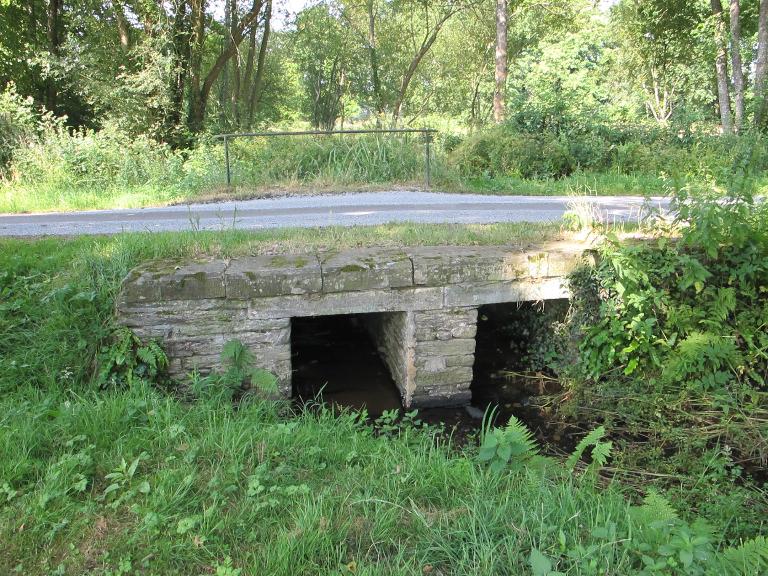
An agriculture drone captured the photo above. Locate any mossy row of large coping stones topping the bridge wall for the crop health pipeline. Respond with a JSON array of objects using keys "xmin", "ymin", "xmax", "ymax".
[{"xmin": 120, "ymin": 242, "xmax": 587, "ymax": 306}]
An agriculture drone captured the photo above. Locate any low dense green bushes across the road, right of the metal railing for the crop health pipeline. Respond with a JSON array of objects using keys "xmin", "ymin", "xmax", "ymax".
[{"xmin": 448, "ymin": 125, "xmax": 768, "ymax": 185}]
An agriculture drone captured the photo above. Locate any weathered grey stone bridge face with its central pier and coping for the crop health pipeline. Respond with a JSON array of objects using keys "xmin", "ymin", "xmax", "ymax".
[{"xmin": 117, "ymin": 244, "xmax": 584, "ymax": 408}]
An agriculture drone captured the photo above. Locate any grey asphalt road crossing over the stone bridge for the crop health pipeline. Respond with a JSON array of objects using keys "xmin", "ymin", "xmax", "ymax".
[{"xmin": 0, "ymin": 190, "xmax": 667, "ymax": 236}]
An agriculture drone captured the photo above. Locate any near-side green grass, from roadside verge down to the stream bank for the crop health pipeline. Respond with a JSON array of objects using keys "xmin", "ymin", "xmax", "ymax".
[{"xmin": 0, "ymin": 224, "xmax": 760, "ymax": 576}]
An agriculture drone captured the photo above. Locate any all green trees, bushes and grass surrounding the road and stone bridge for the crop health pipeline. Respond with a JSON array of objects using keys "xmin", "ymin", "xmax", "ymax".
[{"xmin": 0, "ymin": 0, "xmax": 768, "ymax": 576}]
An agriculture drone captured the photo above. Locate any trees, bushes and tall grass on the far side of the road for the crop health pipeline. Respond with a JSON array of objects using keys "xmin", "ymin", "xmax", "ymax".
[{"xmin": 0, "ymin": 0, "xmax": 768, "ymax": 212}]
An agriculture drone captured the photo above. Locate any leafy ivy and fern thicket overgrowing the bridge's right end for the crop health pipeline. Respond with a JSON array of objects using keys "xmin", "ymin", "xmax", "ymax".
[{"xmin": 560, "ymin": 183, "xmax": 768, "ymax": 534}]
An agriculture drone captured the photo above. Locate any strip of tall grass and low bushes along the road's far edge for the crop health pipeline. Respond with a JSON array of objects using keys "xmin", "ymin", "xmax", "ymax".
[{"xmin": 0, "ymin": 127, "xmax": 768, "ymax": 213}]
